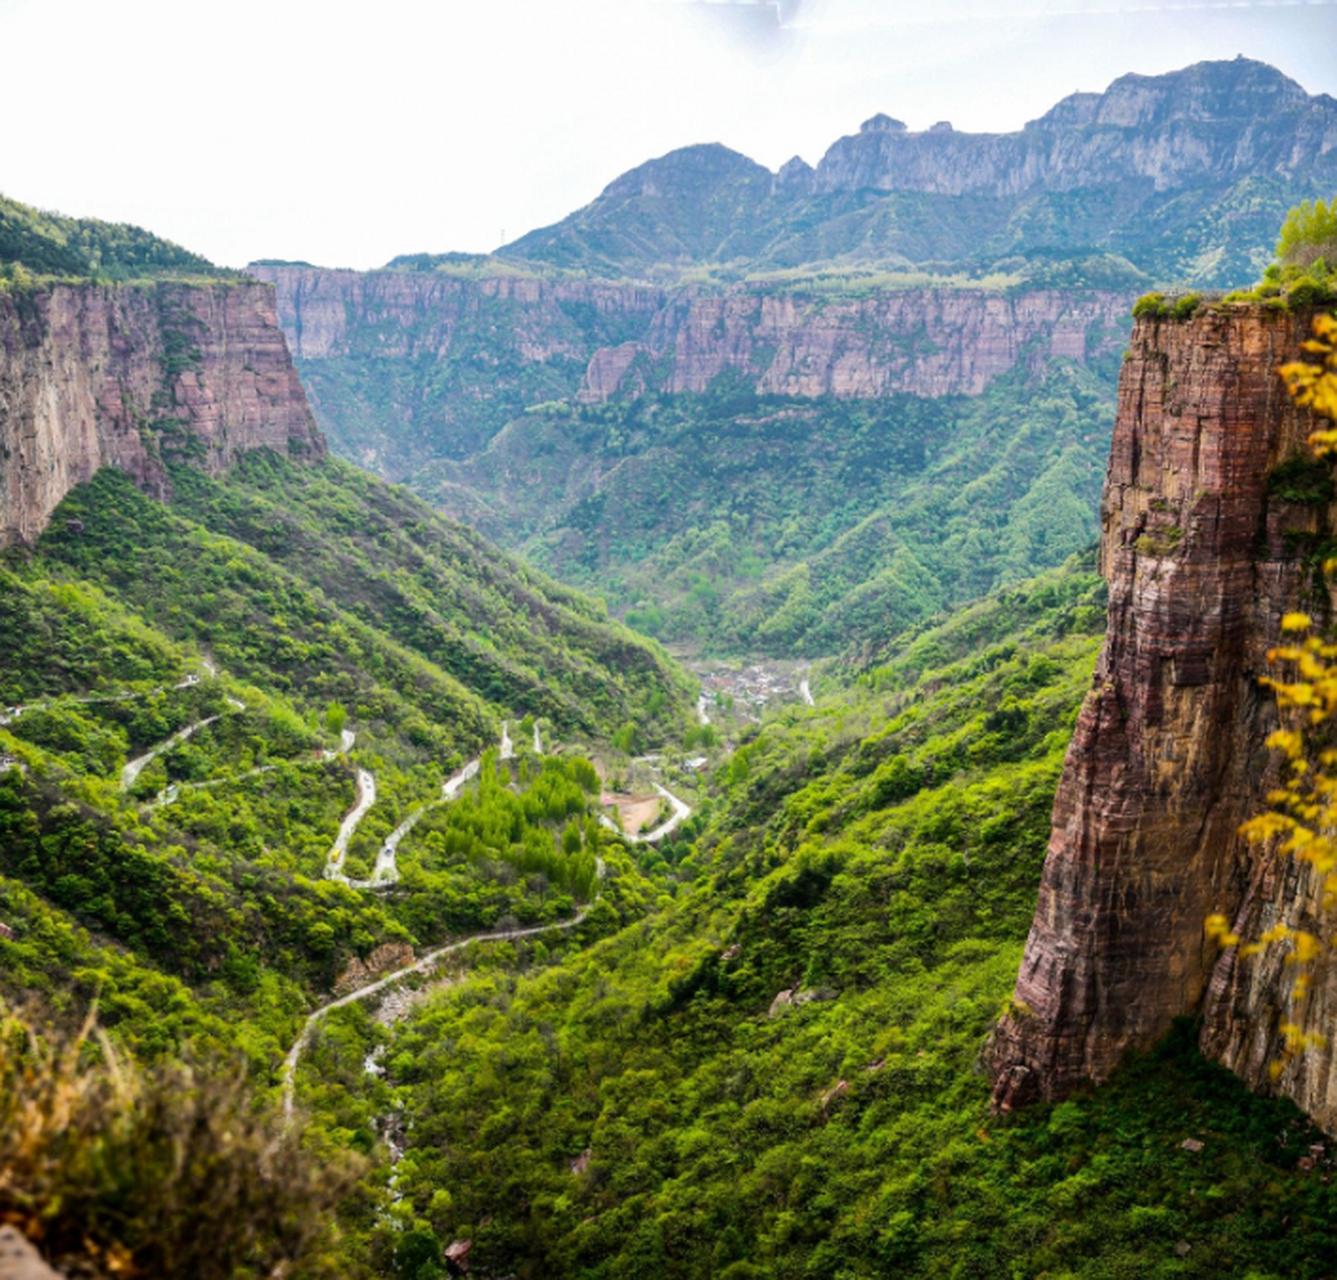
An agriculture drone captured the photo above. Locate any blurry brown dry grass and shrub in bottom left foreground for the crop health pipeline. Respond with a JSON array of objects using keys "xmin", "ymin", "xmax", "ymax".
[{"xmin": 0, "ymin": 1006, "xmax": 360, "ymax": 1280}]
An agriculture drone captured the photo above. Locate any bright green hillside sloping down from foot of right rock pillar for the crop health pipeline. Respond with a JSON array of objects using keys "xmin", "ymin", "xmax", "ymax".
[{"xmin": 290, "ymin": 564, "xmax": 1337, "ymax": 1280}]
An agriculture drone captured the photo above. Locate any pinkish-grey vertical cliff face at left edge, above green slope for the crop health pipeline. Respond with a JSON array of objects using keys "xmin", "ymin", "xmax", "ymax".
[{"xmin": 0, "ymin": 282, "xmax": 325, "ymax": 546}]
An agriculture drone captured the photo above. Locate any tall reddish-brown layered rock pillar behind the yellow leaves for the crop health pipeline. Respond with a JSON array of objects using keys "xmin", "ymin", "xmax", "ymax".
[{"xmin": 989, "ymin": 306, "xmax": 1337, "ymax": 1132}]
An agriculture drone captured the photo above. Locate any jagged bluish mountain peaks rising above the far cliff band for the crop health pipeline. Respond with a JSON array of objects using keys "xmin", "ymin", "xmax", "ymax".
[{"xmin": 489, "ymin": 58, "xmax": 1337, "ymax": 286}]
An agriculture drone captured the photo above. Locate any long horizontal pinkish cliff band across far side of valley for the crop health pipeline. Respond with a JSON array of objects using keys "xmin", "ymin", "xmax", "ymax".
[{"xmin": 250, "ymin": 265, "xmax": 1131, "ymax": 403}]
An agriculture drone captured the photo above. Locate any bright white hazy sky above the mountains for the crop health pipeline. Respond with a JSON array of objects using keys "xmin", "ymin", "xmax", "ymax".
[{"xmin": 0, "ymin": 0, "xmax": 1337, "ymax": 268}]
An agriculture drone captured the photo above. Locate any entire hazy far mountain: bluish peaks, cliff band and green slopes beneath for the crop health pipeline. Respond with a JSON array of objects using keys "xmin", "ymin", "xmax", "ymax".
[{"xmin": 243, "ymin": 59, "xmax": 1337, "ymax": 657}]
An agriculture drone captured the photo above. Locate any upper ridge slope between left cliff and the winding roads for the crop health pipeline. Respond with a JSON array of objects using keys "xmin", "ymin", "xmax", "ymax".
[{"xmin": 41, "ymin": 453, "xmax": 689, "ymax": 733}]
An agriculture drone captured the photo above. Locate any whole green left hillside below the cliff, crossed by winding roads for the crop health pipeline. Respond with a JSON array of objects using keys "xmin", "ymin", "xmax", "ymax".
[{"xmin": 0, "ymin": 456, "xmax": 690, "ymax": 1071}]
